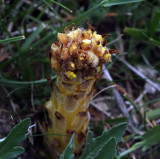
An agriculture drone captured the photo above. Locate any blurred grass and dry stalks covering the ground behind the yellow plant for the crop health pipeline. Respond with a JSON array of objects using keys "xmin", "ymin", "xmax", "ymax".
[{"xmin": 0, "ymin": 0, "xmax": 160, "ymax": 159}]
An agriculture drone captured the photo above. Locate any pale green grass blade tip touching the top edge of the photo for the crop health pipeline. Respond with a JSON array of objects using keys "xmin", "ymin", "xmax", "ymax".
[{"xmin": 101, "ymin": 0, "xmax": 144, "ymax": 7}]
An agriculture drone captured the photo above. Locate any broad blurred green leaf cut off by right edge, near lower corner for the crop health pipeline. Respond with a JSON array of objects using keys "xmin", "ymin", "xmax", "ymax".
[{"xmin": 142, "ymin": 125, "xmax": 160, "ymax": 151}]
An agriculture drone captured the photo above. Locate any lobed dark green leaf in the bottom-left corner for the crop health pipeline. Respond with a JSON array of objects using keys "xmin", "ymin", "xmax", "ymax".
[{"xmin": 0, "ymin": 118, "xmax": 30, "ymax": 159}]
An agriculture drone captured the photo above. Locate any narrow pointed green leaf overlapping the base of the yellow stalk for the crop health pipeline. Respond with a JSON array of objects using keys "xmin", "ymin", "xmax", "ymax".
[{"xmin": 60, "ymin": 134, "xmax": 75, "ymax": 159}]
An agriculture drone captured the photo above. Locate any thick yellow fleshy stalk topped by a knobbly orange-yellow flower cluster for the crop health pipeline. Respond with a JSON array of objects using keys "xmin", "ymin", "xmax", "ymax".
[{"xmin": 45, "ymin": 24, "xmax": 118, "ymax": 155}]
